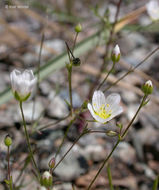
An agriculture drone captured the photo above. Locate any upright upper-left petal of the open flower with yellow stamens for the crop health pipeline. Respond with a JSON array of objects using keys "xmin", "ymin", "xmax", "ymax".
[{"xmin": 92, "ymin": 90, "xmax": 106, "ymax": 111}]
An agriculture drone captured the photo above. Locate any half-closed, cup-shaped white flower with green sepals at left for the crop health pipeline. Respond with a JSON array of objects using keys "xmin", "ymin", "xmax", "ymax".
[{"xmin": 10, "ymin": 69, "xmax": 37, "ymax": 101}]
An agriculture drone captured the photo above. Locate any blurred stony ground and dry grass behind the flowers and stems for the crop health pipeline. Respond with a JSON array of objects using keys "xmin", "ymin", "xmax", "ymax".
[{"xmin": 0, "ymin": 0, "xmax": 159, "ymax": 190}]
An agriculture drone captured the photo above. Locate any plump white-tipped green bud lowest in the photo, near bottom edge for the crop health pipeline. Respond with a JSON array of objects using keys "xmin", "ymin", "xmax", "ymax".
[{"xmin": 40, "ymin": 171, "xmax": 53, "ymax": 188}]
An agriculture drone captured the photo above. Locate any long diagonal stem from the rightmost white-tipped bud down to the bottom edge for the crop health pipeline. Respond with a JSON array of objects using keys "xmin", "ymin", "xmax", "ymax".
[{"xmin": 87, "ymin": 95, "xmax": 147, "ymax": 190}]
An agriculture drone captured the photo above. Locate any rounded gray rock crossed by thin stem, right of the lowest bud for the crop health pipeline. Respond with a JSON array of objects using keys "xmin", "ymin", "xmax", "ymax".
[{"xmin": 54, "ymin": 143, "xmax": 88, "ymax": 181}]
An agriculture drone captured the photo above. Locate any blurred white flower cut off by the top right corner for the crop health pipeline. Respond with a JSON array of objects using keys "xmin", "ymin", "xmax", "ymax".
[{"xmin": 146, "ymin": 0, "xmax": 159, "ymax": 20}]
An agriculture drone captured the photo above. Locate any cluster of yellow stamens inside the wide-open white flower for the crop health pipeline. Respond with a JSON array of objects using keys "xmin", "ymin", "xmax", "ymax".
[{"xmin": 95, "ymin": 104, "xmax": 112, "ymax": 119}]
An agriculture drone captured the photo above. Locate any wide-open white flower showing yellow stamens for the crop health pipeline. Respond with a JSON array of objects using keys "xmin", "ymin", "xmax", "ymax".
[{"xmin": 87, "ymin": 90, "xmax": 123, "ymax": 123}]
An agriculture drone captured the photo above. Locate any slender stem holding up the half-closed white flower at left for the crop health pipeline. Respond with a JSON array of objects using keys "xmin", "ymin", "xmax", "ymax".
[{"xmin": 19, "ymin": 101, "xmax": 40, "ymax": 179}]
